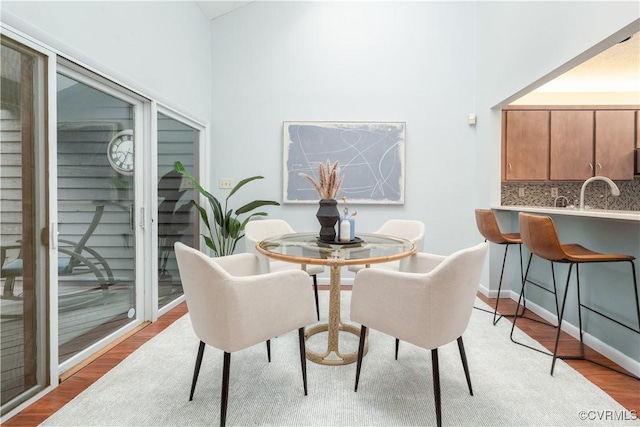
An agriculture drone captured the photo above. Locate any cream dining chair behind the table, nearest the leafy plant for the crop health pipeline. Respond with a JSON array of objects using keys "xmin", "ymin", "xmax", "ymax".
[{"xmin": 244, "ymin": 219, "xmax": 324, "ymax": 320}]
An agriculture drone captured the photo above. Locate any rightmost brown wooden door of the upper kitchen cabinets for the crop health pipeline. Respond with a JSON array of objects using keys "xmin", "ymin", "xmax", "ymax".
[{"xmin": 595, "ymin": 110, "xmax": 635, "ymax": 180}]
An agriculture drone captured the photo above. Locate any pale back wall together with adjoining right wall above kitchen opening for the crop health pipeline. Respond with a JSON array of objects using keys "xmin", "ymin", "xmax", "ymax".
[{"xmin": 212, "ymin": 2, "xmax": 638, "ymax": 287}]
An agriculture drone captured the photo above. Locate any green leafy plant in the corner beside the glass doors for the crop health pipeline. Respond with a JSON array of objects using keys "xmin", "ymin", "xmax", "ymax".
[{"xmin": 174, "ymin": 162, "xmax": 280, "ymax": 256}]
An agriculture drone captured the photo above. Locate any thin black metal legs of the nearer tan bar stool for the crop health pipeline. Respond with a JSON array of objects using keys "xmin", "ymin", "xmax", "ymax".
[{"xmin": 551, "ymin": 260, "xmax": 640, "ymax": 380}]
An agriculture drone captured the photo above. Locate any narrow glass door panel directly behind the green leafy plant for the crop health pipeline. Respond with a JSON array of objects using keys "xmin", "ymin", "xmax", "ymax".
[{"xmin": 158, "ymin": 113, "xmax": 199, "ymax": 308}]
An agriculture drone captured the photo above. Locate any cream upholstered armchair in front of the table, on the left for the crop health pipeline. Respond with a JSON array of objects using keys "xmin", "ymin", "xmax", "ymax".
[{"xmin": 175, "ymin": 242, "xmax": 315, "ymax": 426}]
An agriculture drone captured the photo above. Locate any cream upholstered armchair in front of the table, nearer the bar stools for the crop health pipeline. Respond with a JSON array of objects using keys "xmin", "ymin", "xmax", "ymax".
[{"xmin": 351, "ymin": 242, "xmax": 487, "ymax": 426}]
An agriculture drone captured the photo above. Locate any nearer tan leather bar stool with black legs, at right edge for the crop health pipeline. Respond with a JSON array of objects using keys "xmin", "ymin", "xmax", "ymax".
[{"xmin": 514, "ymin": 212, "xmax": 640, "ymax": 379}]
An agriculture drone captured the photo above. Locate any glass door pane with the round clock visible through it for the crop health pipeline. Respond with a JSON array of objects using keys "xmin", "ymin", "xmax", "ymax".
[{"xmin": 57, "ymin": 74, "xmax": 136, "ymax": 363}]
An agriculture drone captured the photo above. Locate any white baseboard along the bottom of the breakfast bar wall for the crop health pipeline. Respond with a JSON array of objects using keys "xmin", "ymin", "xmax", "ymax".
[{"xmin": 510, "ymin": 291, "xmax": 640, "ymax": 377}]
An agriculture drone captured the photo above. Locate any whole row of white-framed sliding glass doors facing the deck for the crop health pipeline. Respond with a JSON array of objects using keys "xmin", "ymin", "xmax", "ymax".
[{"xmin": 0, "ymin": 27, "xmax": 205, "ymax": 417}]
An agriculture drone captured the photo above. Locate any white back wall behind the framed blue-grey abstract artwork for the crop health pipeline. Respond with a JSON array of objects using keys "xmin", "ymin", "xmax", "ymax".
[{"xmin": 211, "ymin": 2, "xmax": 480, "ymax": 264}]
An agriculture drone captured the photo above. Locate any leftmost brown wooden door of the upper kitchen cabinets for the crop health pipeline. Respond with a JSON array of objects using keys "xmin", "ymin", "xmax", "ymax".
[{"xmin": 504, "ymin": 111, "xmax": 549, "ymax": 181}]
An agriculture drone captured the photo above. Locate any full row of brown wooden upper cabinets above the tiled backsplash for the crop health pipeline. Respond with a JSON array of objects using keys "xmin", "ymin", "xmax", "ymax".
[{"xmin": 502, "ymin": 105, "xmax": 640, "ymax": 181}]
